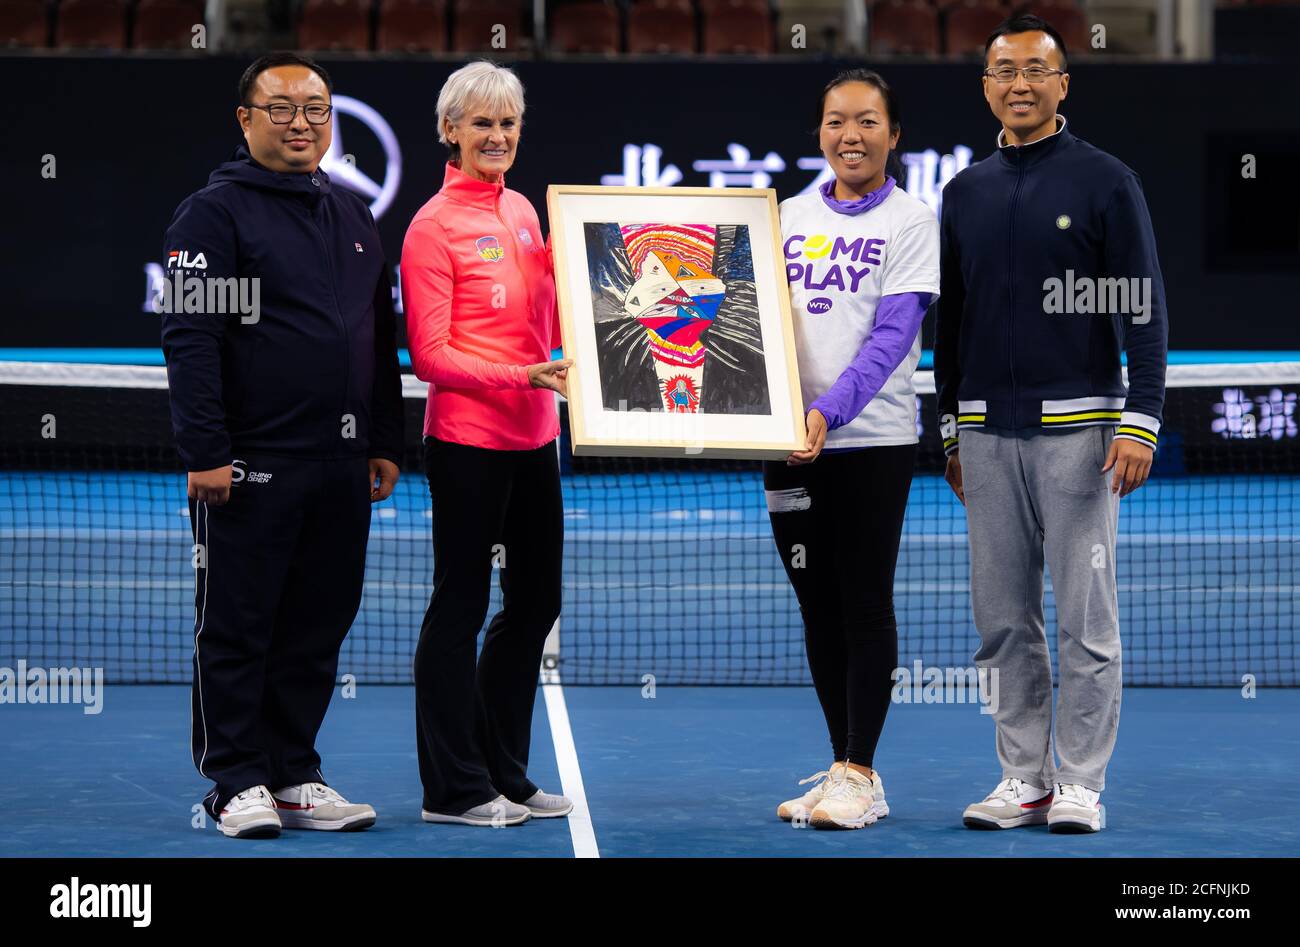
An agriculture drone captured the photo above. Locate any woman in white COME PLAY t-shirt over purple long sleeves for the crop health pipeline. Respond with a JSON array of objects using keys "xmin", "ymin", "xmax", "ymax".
[{"xmin": 763, "ymin": 69, "xmax": 939, "ymax": 829}]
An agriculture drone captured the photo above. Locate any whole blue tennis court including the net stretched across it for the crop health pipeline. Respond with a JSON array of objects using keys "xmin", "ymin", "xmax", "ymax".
[{"xmin": 0, "ymin": 364, "xmax": 1300, "ymax": 857}]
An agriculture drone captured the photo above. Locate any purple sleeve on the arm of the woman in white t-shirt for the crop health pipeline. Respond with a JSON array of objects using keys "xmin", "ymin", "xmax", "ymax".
[{"xmin": 809, "ymin": 293, "xmax": 932, "ymax": 431}]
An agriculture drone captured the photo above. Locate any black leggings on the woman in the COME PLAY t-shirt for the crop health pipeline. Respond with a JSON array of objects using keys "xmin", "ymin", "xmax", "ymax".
[{"xmin": 763, "ymin": 444, "xmax": 917, "ymax": 766}]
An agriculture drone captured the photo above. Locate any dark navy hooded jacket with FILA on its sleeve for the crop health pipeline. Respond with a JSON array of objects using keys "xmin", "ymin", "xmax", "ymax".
[{"xmin": 163, "ymin": 146, "xmax": 403, "ymax": 471}]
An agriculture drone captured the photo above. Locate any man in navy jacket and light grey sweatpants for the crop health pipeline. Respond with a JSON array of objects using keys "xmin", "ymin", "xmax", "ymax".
[{"xmin": 935, "ymin": 16, "xmax": 1167, "ymax": 831}]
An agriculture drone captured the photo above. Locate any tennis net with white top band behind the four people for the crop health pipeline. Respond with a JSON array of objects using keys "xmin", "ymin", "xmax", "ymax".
[{"xmin": 0, "ymin": 363, "xmax": 1300, "ymax": 687}]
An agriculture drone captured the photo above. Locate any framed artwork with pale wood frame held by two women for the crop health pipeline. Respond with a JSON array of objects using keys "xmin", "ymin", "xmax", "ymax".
[{"xmin": 546, "ymin": 185, "xmax": 805, "ymax": 459}]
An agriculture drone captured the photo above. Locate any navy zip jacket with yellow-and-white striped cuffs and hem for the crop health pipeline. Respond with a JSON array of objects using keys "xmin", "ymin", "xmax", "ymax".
[{"xmin": 935, "ymin": 118, "xmax": 1169, "ymax": 454}]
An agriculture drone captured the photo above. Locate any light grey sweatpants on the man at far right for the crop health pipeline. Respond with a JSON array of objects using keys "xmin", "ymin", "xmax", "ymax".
[{"xmin": 959, "ymin": 427, "xmax": 1121, "ymax": 792}]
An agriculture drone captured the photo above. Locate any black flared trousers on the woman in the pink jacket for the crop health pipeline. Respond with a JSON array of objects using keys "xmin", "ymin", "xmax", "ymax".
[{"xmin": 415, "ymin": 437, "xmax": 564, "ymax": 814}]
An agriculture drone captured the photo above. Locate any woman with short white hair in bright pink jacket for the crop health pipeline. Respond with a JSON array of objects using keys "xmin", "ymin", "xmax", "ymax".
[{"xmin": 402, "ymin": 62, "xmax": 572, "ymax": 826}]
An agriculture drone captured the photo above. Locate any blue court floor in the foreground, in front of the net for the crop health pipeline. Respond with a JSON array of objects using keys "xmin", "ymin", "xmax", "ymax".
[{"xmin": 0, "ymin": 686, "xmax": 1300, "ymax": 857}]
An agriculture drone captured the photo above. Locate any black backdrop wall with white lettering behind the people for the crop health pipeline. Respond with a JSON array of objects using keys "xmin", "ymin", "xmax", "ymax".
[{"xmin": 0, "ymin": 56, "xmax": 1300, "ymax": 349}]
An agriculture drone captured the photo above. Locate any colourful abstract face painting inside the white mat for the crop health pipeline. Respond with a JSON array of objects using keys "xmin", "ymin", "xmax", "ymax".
[{"xmin": 584, "ymin": 222, "xmax": 771, "ymax": 415}]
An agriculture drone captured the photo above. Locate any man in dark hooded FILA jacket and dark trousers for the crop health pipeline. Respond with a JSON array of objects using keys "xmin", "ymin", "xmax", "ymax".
[{"xmin": 159, "ymin": 53, "xmax": 402, "ymax": 838}]
